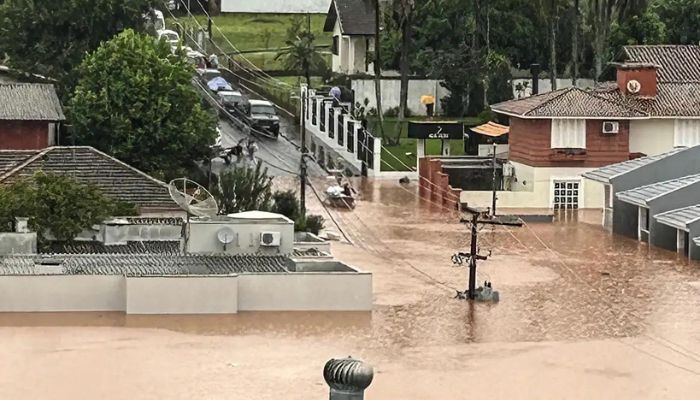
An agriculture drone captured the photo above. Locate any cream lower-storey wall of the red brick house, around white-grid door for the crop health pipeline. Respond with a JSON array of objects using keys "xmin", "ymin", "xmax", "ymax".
[{"xmin": 460, "ymin": 161, "xmax": 605, "ymax": 210}]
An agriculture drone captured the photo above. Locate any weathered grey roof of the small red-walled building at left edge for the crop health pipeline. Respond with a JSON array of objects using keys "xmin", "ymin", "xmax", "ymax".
[{"xmin": 0, "ymin": 83, "xmax": 66, "ymax": 121}]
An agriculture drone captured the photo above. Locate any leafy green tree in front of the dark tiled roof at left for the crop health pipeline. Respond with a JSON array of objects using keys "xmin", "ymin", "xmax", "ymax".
[{"xmin": 0, "ymin": 172, "xmax": 136, "ymax": 242}]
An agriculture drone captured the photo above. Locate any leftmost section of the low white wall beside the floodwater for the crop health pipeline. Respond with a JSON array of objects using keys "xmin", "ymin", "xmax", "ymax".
[{"xmin": 0, "ymin": 275, "xmax": 126, "ymax": 312}]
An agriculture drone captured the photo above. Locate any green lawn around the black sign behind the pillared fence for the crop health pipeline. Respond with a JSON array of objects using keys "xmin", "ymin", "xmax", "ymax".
[{"xmin": 369, "ymin": 117, "xmax": 480, "ymax": 171}]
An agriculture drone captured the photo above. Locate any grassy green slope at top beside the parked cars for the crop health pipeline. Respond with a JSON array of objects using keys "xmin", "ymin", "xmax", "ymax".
[{"xmin": 167, "ymin": 14, "xmax": 332, "ymax": 71}]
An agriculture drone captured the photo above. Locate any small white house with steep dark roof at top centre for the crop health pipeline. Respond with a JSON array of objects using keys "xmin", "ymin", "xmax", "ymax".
[{"xmin": 323, "ymin": 0, "xmax": 377, "ymax": 74}]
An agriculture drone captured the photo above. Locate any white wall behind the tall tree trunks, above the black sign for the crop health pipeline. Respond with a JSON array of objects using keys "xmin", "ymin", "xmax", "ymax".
[{"xmin": 351, "ymin": 79, "xmax": 450, "ymax": 115}]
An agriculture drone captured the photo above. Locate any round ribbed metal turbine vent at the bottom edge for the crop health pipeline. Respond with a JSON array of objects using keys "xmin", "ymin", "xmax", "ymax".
[{"xmin": 323, "ymin": 356, "xmax": 374, "ymax": 400}]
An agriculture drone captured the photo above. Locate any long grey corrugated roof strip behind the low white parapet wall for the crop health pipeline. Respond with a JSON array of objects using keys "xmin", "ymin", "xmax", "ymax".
[{"xmin": 0, "ymin": 254, "xmax": 289, "ymax": 276}]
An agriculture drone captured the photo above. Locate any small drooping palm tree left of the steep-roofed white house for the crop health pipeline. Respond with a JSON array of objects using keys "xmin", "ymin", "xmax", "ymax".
[{"xmin": 275, "ymin": 14, "xmax": 326, "ymax": 87}]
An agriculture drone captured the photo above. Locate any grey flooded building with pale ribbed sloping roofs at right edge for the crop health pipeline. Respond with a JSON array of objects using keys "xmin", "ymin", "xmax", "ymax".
[{"xmin": 583, "ymin": 145, "xmax": 700, "ymax": 259}]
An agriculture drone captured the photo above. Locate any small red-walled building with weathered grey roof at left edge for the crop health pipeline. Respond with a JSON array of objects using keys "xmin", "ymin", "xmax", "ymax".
[{"xmin": 0, "ymin": 82, "xmax": 65, "ymax": 150}]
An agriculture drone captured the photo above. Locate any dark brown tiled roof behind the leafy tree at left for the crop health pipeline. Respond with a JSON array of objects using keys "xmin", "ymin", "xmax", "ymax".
[{"xmin": 0, "ymin": 146, "xmax": 180, "ymax": 216}]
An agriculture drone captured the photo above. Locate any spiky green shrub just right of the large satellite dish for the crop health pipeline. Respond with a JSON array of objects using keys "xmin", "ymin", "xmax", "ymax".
[{"xmin": 214, "ymin": 163, "xmax": 272, "ymax": 214}]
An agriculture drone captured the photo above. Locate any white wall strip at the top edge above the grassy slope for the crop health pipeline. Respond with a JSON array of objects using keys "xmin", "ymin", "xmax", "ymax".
[{"xmin": 221, "ymin": 0, "xmax": 331, "ymax": 14}]
